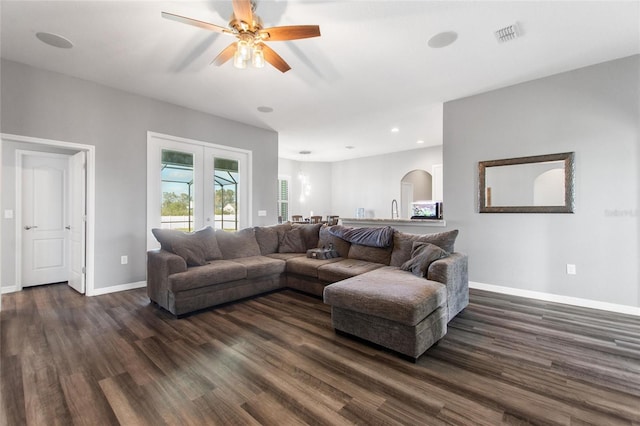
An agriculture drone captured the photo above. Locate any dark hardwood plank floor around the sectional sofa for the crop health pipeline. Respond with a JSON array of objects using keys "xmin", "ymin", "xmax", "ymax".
[{"xmin": 0, "ymin": 284, "xmax": 640, "ymax": 425}]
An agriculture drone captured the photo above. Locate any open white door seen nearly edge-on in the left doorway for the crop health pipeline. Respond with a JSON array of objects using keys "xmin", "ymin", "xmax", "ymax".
[{"xmin": 67, "ymin": 151, "xmax": 87, "ymax": 294}]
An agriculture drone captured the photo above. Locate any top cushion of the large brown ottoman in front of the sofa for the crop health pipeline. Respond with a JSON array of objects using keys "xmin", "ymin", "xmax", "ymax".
[{"xmin": 324, "ymin": 266, "xmax": 447, "ymax": 326}]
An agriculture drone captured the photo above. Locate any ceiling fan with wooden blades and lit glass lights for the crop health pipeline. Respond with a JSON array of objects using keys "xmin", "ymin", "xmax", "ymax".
[{"xmin": 162, "ymin": 0, "xmax": 320, "ymax": 73}]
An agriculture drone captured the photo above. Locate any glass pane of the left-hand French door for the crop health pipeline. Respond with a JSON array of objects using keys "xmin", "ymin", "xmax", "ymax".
[{"xmin": 160, "ymin": 149, "xmax": 194, "ymax": 232}]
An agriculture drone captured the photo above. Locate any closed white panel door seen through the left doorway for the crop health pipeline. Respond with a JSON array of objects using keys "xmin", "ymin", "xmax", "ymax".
[{"xmin": 21, "ymin": 154, "xmax": 69, "ymax": 287}]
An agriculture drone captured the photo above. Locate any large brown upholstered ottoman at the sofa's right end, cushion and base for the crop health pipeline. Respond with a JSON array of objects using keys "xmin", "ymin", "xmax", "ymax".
[{"xmin": 324, "ymin": 266, "xmax": 447, "ymax": 362}]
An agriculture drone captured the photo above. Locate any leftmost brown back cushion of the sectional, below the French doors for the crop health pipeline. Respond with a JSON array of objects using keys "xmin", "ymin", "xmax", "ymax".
[{"xmin": 151, "ymin": 226, "xmax": 222, "ymax": 266}]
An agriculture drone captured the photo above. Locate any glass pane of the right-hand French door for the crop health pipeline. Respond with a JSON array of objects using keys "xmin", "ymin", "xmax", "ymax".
[{"xmin": 213, "ymin": 157, "xmax": 240, "ymax": 231}]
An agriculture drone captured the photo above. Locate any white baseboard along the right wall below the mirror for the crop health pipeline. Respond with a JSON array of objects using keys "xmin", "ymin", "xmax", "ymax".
[{"xmin": 469, "ymin": 281, "xmax": 640, "ymax": 316}]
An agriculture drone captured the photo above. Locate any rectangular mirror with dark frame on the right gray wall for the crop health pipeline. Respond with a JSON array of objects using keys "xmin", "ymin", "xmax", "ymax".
[{"xmin": 478, "ymin": 153, "xmax": 573, "ymax": 213}]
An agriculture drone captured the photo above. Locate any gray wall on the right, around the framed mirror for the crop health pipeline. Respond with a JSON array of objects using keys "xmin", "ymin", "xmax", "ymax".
[{"xmin": 443, "ymin": 55, "xmax": 640, "ymax": 306}]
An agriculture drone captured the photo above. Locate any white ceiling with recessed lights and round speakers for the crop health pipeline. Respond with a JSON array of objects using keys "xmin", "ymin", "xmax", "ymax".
[{"xmin": 0, "ymin": 0, "xmax": 640, "ymax": 161}]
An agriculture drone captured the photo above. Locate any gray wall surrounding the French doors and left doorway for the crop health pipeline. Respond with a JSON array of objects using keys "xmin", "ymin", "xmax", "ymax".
[{"xmin": 0, "ymin": 60, "xmax": 278, "ymax": 289}]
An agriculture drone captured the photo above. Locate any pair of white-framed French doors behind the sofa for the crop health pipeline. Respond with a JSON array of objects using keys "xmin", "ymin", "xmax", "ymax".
[{"xmin": 147, "ymin": 132, "xmax": 251, "ymax": 248}]
